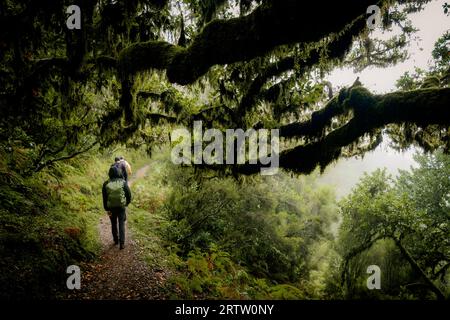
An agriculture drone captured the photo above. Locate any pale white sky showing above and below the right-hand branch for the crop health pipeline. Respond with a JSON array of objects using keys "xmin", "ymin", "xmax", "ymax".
[{"xmin": 319, "ymin": 0, "xmax": 450, "ymax": 198}]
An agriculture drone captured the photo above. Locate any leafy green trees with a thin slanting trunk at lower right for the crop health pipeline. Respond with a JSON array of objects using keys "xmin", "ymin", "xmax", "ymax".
[{"xmin": 338, "ymin": 152, "xmax": 450, "ymax": 299}]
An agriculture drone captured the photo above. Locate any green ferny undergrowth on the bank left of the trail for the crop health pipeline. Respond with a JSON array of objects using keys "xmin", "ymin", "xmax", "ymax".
[{"xmin": 0, "ymin": 149, "xmax": 118, "ymax": 299}]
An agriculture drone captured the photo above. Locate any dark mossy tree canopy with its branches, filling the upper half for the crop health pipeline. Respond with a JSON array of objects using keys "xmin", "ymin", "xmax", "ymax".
[{"xmin": 0, "ymin": 0, "xmax": 450, "ymax": 174}]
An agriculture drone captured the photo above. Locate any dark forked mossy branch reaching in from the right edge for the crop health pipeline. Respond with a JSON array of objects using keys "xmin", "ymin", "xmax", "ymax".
[{"xmin": 198, "ymin": 87, "xmax": 450, "ymax": 175}]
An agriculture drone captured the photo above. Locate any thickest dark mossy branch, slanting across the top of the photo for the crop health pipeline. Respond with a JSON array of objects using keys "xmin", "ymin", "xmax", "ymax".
[{"xmin": 119, "ymin": 0, "xmax": 373, "ymax": 85}]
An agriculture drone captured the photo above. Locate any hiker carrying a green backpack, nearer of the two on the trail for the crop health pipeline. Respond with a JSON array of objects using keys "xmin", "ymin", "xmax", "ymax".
[{"xmin": 102, "ymin": 166, "xmax": 131, "ymax": 249}]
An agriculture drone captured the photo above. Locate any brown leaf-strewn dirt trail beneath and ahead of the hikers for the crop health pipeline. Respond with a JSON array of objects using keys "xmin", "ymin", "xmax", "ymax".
[{"xmin": 68, "ymin": 165, "xmax": 166, "ymax": 300}]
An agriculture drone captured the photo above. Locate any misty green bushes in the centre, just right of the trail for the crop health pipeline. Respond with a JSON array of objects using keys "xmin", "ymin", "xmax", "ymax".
[{"xmin": 156, "ymin": 153, "xmax": 336, "ymax": 298}]
